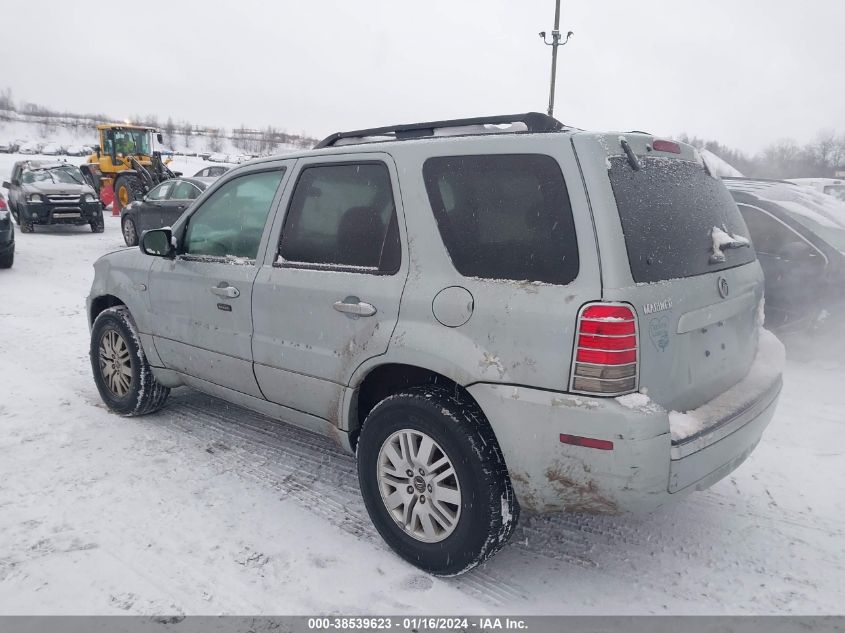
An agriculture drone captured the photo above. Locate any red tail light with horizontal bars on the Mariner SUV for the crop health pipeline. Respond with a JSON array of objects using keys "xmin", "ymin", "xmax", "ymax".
[{"xmin": 570, "ymin": 303, "xmax": 639, "ymax": 396}]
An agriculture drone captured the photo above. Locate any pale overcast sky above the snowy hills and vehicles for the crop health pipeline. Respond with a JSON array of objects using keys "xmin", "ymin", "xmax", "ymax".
[{"xmin": 0, "ymin": 0, "xmax": 845, "ymax": 152}]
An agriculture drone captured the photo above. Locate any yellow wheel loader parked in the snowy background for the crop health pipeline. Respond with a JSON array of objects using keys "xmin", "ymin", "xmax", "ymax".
[{"xmin": 80, "ymin": 124, "xmax": 180, "ymax": 215}]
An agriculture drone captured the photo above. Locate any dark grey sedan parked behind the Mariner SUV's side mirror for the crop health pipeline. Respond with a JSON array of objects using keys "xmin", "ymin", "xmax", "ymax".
[{"xmin": 120, "ymin": 178, "xmax": 215, "ymax": 246}]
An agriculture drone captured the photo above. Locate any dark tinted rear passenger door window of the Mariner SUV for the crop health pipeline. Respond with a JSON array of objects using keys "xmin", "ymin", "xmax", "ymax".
[{"xmin": 279, "ymin": 163, "xmax": 401, "ymax": 273}]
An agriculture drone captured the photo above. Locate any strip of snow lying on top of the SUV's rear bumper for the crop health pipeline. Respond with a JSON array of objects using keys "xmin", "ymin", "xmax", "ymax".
[{"xmin": 669, "ymin": 329, "xmax": 786, "ymax": 441}]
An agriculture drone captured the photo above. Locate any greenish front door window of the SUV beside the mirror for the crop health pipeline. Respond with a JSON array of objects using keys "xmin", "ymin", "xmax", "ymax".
[{"xmin": 183, "ymin": 169, "xmax": 284, "ymax": 260}]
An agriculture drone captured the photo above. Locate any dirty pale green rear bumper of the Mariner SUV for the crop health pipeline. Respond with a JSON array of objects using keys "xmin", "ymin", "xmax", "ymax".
[{"xmin": 469, "ymin": 375, "xmax": 781, "ymax": 514}]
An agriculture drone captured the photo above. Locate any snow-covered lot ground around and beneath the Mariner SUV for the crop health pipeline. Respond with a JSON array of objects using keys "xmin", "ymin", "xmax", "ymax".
[{"xmin": 0, "ymin": 156, "xmax": 845, "ymax": 614}]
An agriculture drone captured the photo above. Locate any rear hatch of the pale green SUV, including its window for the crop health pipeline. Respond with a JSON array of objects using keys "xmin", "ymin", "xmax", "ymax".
[{"xmin": 573, "ymin": 133, "xmax": 763, "ymax": 411}]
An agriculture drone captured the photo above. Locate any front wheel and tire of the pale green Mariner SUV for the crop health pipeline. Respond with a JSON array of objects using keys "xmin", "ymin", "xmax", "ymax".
[{"xmin": 90, "ymin": 306, "xmax": 170, "ymax": 416}]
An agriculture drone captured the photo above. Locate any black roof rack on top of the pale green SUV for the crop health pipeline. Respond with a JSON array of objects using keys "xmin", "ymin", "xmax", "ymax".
[{"xmin": 314, "ymin": 112, "xmax": 566, "ymax": 149}]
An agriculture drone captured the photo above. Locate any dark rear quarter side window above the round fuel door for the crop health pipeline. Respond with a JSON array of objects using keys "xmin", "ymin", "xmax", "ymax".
[{"xmin": 423, "ymin": 154, "xmax": 578, "ymax": 284}]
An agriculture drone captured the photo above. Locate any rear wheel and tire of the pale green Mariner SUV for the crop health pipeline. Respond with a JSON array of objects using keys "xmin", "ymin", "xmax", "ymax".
[{"xmin": 357, "ymin": 385, "xmax": 519, "ymax": 576}]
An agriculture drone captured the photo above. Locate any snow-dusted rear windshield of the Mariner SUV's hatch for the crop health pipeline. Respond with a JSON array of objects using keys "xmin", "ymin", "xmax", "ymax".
[{"xmin": 609, "ymin": 156, "xmax": 756, "ymax": 283}]
